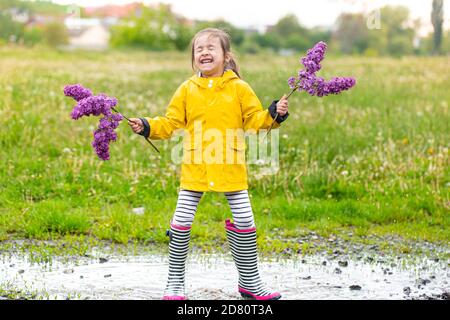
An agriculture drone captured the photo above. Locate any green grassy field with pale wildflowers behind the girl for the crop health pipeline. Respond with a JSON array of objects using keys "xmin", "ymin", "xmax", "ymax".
[{"xmin": 0, "ymin": 48, "xmax": 450, "ymax": 255}]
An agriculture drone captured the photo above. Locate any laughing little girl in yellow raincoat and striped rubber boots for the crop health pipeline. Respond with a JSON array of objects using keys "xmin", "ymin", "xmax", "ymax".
[{"xmin": 128, "ymin": 28, "xmax": 289, "ymax": 300}]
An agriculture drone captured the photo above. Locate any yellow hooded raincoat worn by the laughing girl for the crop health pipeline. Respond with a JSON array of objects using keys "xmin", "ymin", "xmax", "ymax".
[{"xmin": 145, "ymin": 70, "xmax": 280, "ymax": 192}]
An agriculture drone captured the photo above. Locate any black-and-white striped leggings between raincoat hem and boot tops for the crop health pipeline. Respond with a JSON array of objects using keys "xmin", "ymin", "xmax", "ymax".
[{"xmin": 172, "ymin": 189, "xmax": 255, "ymax": 229}]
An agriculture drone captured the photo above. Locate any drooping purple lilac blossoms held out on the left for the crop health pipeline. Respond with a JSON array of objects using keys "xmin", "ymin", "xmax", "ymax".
[{"xmin": 64, "ymin": 84, "xmax": 123, "ymax": 160}]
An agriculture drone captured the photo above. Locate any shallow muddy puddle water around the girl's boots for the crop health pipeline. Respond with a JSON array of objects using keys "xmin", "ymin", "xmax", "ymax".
[{"xmin": 0, "ymin": 253, "xmax": 450, "ymax": 299}]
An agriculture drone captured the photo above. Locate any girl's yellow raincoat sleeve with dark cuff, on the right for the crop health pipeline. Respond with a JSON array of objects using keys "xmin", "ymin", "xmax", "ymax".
[{"xmin": 239, "ymin": 82, "xmax": 289, "ymax": 131}]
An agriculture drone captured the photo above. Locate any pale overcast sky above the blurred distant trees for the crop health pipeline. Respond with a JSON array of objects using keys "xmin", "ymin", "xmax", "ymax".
[{"xmin": 53, "ymin": 0, "xmax": 450, "ymax": 34}]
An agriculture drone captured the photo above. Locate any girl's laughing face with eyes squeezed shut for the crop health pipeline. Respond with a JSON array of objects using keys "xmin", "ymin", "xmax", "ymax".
[{"xmin": 194, "ymin": 34, "xmax": 228, "ymax": 77}]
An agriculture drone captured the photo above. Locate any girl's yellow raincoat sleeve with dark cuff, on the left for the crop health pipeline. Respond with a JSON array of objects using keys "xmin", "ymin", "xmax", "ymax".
[{"xmin": 141, "ymin": 83, "xmax": 186, "ymax": 140}]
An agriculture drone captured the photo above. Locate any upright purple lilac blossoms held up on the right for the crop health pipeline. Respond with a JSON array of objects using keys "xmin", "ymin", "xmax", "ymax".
[{"xmin": 288, "ymin": 41, "xmax": 356, "ymax": 97}]
